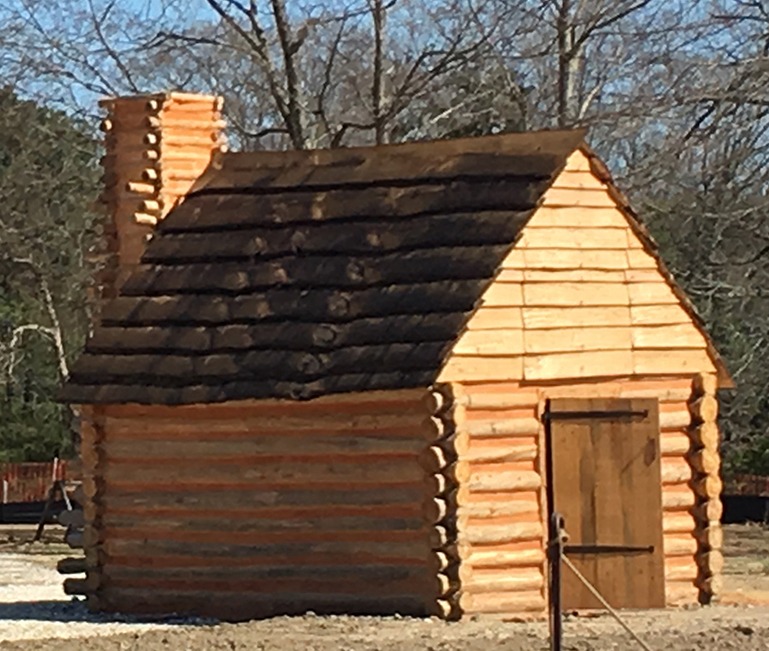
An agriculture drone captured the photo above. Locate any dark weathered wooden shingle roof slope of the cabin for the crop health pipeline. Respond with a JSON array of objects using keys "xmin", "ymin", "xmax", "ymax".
[{"xmin": 62, "ymin": 131, "xmax": 584, "ymax": 404}]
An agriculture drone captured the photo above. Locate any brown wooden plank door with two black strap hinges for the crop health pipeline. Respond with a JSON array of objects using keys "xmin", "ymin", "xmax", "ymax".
[{"xmin": 547, "ymin": 399, "xmax": 665, "ymax": 610}]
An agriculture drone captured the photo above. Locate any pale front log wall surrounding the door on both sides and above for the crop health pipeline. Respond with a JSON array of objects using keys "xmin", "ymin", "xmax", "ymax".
[{"xmin": 455, "ymin": 378, "xmax": 708, "ymax": 618}]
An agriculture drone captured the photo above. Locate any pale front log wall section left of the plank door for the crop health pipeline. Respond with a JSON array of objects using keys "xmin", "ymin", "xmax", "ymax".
[{"xmin": 455, "ymin": 383, "xmax": 547, "ymax": 617}]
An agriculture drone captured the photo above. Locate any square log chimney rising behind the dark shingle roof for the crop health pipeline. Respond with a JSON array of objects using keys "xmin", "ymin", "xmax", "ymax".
[{"xmin": 91, "ymin": 93, "xmax": 224, "ymax": 306}]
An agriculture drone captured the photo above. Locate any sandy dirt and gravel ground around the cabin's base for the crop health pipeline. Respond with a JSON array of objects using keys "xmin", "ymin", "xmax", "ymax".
[{"xmin": 0, "ymin": 526, "xmax": 769, "ymax": 651}]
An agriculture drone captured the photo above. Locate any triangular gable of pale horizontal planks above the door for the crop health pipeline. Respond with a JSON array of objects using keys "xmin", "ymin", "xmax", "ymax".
[{"xmin": 440, "ymin": 152, "xmax": 714, "ymax": 383}]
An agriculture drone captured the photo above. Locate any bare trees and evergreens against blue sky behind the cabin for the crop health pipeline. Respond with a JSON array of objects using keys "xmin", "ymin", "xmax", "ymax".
[{"xmin": 0, "ymin": 0, "xmax": 769, "ymax": 473}]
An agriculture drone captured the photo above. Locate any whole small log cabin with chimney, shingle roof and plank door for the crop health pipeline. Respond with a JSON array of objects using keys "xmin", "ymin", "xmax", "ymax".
[{"xmin": 62, "ymin": 93, "xmax": 732, "ymax": 620}]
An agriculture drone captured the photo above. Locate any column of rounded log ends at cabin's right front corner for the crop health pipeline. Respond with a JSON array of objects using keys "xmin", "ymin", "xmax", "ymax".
[{"xmin": 689, "ymin": 374, "xmax": 724, "ymax": 603}]
